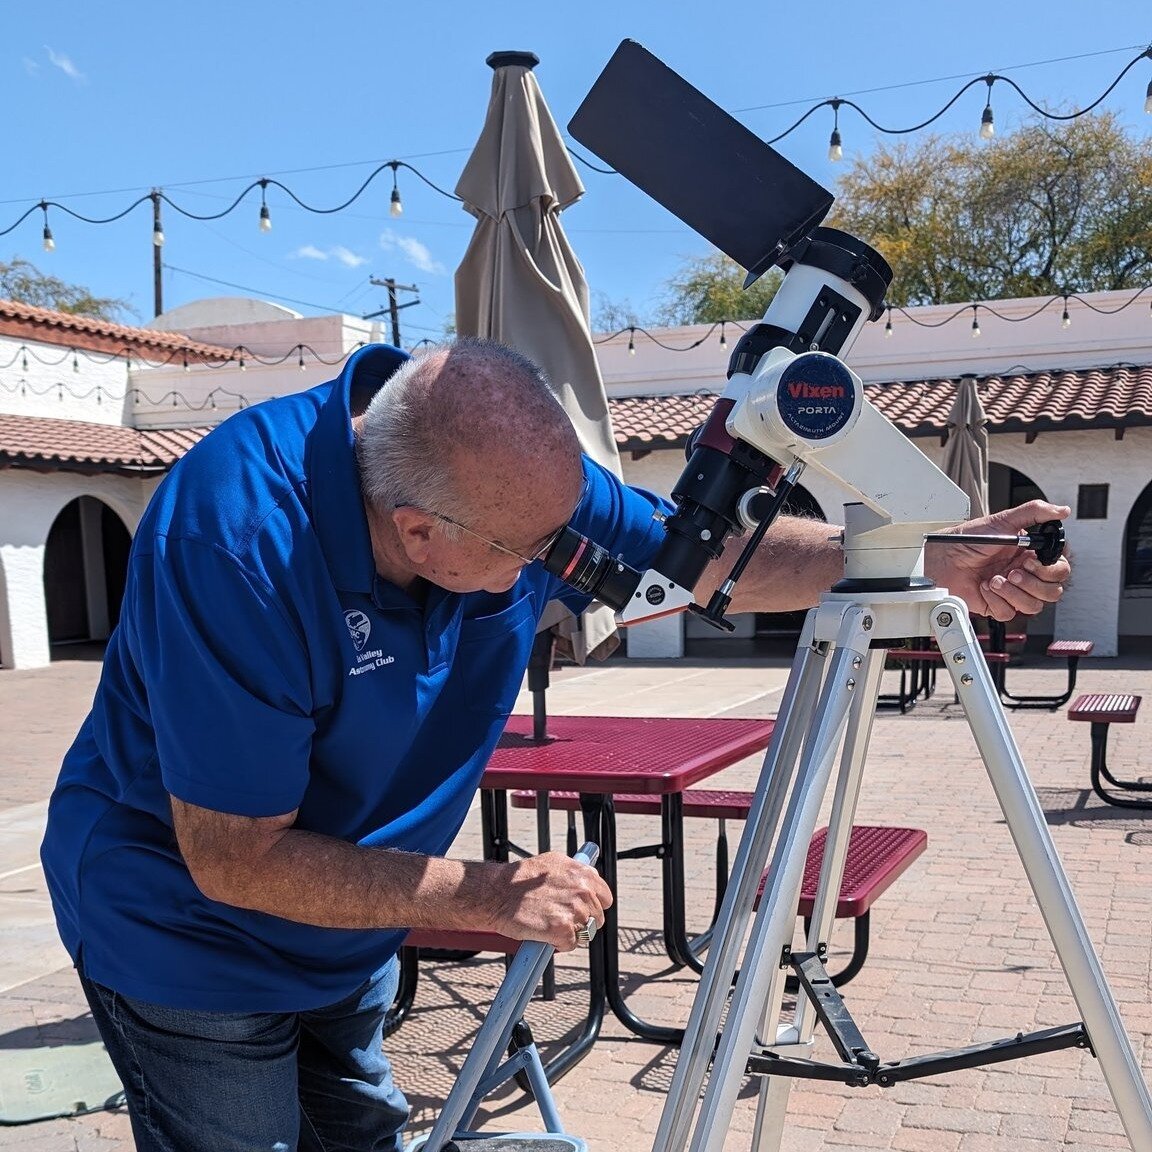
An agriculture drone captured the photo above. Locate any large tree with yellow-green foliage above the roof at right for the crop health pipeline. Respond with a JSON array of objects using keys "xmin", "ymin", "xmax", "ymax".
[{"xmin": 828, "ymin": 113, "xmax": 1152, "ymax": 304}]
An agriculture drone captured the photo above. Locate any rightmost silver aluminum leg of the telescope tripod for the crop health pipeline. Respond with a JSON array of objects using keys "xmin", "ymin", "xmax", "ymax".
[{"xmin": 932, "ymin": 600, "xmax": 1152, "ymax": 1152}]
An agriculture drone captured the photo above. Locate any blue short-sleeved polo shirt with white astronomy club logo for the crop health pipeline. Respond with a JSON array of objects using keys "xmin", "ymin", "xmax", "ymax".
[{"xmin": 41, "ymin": 346, "xmax": 661, "ymax": 1011}]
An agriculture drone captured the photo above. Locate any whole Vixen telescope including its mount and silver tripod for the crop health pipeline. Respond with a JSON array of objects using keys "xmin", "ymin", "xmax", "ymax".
[{"xmin": 536, "ymin": 40, "xmax": 1152, "ymax": 1152}]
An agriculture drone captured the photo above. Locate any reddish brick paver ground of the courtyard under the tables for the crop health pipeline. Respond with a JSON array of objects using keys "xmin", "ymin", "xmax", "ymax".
[{"xmin": 0, "ymin": 657, "xmax": 1152, "ymax": 1152}]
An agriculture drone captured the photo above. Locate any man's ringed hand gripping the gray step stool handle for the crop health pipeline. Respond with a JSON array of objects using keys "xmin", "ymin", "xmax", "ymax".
[{"xmin": 493, "ymin": 852, "xmax": 612, "ymax": 952}]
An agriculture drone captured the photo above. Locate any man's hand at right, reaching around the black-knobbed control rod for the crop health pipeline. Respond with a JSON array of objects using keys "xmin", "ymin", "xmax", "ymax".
[{"xmin": 925, "ymin": 500, "xmax": 1071, "ymax": 621}]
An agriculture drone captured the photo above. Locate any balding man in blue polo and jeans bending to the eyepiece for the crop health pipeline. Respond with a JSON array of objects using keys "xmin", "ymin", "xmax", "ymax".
[{"xmin": 43, "ymin": 341, "xmax": 1068, "ymax": 1152}]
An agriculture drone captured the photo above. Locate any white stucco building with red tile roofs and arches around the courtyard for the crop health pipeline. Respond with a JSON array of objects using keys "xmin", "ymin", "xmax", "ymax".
[{"xmin": 0, "ymin": 293, "xmax": 1152, "ymax": 667}]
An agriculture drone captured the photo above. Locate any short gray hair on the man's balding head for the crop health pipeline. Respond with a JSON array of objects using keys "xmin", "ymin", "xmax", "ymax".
[{"xmin": 356, "ymin": 338, "xmax": 567, "ymax": 513}]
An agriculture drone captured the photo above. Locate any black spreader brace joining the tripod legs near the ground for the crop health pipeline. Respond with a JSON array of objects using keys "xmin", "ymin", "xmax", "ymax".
[{"xmin": 746, "ymin": 952, "xmax": 1094, "ymax": 1087}]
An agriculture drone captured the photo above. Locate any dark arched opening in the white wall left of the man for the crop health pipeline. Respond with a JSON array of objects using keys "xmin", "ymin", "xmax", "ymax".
[{"xmin": 44, "ymin": 497, "xmax": 131, "ymax": 658}]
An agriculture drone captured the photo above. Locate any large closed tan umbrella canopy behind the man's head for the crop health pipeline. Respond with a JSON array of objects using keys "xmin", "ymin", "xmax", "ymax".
[{"xmin": 456, "ymin": 52, "xmax": 620, "ymax": 664}]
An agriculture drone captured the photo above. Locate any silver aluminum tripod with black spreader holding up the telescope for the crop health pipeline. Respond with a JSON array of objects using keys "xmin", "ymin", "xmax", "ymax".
[{"xmin": 654, "ymin": 581, "xmax": 1152, "ymax": 1152}]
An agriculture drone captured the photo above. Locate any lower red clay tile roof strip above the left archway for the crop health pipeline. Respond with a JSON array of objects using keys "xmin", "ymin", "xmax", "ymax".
[{"xmin": 0, "ymin": 414, "xmax": 210, "ymax": 476}]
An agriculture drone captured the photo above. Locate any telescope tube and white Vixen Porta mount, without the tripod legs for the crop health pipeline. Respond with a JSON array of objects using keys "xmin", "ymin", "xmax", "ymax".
[{"xmin": 545, "ymin": 40, "xmax": 1063, "ymax": 630}]
